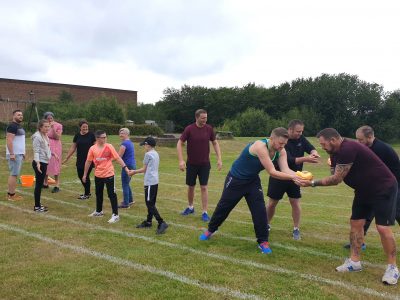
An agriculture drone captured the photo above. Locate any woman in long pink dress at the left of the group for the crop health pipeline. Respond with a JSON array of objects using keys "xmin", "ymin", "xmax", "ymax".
[{"xmin": 43, "ymin": 111, "xmax": 63, "ymax": 193}]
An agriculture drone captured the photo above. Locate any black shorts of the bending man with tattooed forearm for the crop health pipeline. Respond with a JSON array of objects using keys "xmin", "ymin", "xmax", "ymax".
[{"xmin": 351, "ymin": 184, "xmax": 397, "ymax": 226}]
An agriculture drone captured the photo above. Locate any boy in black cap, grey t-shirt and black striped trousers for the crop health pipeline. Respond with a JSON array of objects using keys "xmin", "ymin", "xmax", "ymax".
[{"xmin": 128, "ymin": 137, "xmax": 168, "ymax": 234}]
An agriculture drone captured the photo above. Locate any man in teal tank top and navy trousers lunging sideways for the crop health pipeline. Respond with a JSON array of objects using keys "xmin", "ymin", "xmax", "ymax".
[{"xmin": 200, "ymin": 127, "xmax": 297, "ymax": 254}]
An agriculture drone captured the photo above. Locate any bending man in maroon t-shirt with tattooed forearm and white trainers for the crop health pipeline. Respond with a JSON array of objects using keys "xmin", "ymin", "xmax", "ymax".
[{"xmin": 297, "ymin": 128, "xmax": 399, "ymax": 284}]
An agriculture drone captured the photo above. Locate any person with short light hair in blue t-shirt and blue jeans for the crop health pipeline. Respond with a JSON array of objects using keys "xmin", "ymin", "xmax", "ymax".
[{"xmin": 118, "ymin": 128, "xmax": 136, "ymax": 208}]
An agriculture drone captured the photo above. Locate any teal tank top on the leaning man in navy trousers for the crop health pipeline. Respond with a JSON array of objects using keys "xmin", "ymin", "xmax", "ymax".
[{"xmin": 230, "ymin": 139, "xmax": 279, "ymax": 180}]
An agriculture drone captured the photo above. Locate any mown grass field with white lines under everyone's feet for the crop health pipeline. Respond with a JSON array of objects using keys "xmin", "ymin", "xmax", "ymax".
[{"xmin": 0, "ymin": 136, "xmax": 400, "ymax": 299}]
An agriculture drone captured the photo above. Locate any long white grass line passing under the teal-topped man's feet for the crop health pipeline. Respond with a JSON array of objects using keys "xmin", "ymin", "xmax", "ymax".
[{"xmin": 11, "ymin": 192, "xmax": 385, "ymax": 269}]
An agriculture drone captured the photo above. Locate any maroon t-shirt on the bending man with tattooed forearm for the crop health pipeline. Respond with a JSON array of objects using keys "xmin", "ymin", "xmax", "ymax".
[{"xmin": 331, "ymin": 139, "xmax": 396, "ymax": 198}]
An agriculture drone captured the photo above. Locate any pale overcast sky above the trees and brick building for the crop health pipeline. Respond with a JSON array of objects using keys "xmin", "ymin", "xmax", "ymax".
[{"xmin": 0, "ymin": 0, "xmax": 400, "ymax": 103}]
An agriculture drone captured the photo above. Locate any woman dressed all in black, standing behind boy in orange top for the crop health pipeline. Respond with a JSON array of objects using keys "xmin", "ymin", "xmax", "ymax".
[{"xmin": 63, "ymin": 120, "xmax": 96, "ymax": 200}]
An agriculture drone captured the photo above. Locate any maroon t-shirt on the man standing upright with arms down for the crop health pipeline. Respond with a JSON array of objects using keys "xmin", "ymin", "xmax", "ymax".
[{"xmin": 180, "ymin": 123, "xmax": 215, "ymax": 166}]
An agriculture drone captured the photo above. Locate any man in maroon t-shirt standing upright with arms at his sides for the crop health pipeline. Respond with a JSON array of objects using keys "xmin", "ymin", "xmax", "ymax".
[{"xmin": 176, "ymin": 109, "xmax": 222, "ymax": 222}]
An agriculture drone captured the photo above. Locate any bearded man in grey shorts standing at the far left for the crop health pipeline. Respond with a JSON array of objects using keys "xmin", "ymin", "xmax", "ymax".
[{"xmin": 6, "ymin": 109, "xmax": 25, "ymax": 201}]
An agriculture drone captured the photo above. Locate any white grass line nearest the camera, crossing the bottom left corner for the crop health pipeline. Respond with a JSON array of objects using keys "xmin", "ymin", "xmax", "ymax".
[{"xmin": 0, "ymin": 223, "xmax": 262, "ymax": 299}]
